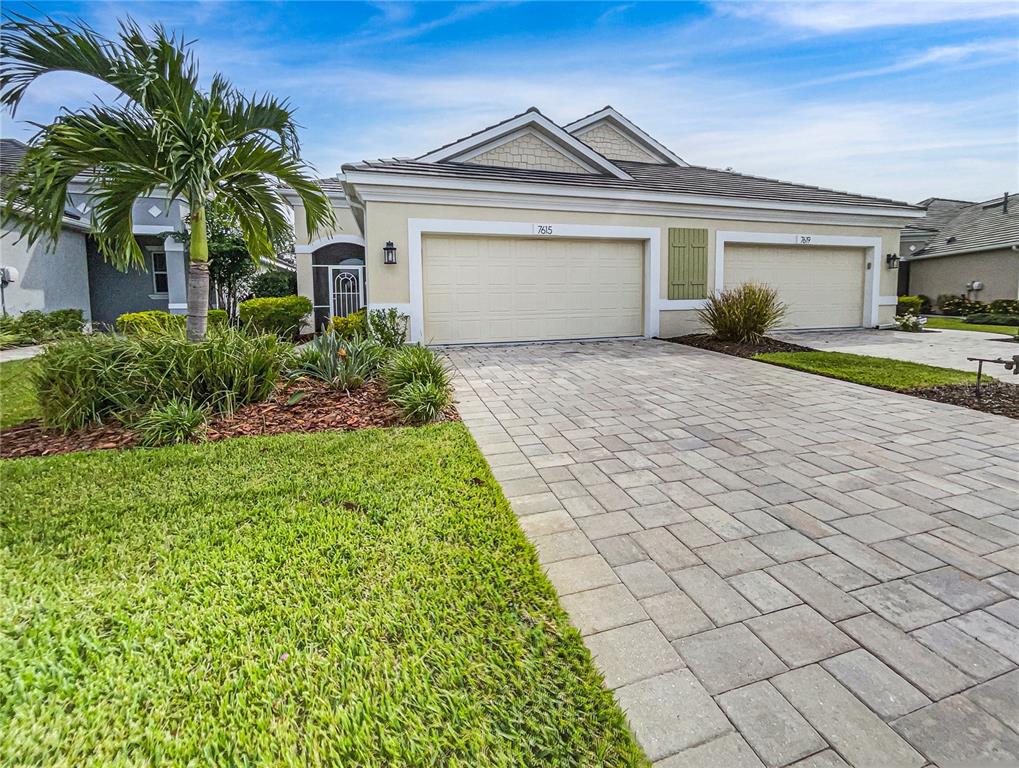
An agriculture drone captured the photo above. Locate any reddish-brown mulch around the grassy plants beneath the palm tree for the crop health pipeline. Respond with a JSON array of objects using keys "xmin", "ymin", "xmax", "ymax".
[{"xmin": 0, "ymin": 379, "xmax": 460, "ymax": 458}]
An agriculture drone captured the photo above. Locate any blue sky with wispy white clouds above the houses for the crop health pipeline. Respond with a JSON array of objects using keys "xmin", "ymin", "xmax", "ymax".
[{"xmin": 2, "ymin": 0, "xmax": 1019, "ymax": 202}]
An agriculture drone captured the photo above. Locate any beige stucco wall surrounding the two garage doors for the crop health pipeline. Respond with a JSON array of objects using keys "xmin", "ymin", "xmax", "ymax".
[{"xmin": 365, "ymin": 195, "xmax": 899, "ymax": 336}]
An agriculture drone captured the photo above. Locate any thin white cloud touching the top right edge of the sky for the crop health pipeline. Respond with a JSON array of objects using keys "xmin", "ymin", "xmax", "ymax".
[{"xmin": 715, "ymin": 0, "xmax": 1019, "ymax": 34}]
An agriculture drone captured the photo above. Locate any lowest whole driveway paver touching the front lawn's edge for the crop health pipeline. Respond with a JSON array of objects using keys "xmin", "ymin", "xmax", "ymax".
[{"xmin": 615, "ymin": 669, "xmax": 733, "ymax": 760}]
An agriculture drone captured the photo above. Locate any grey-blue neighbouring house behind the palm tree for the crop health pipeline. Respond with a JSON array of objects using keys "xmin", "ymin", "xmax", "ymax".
[{"xmin": 0, "ymin": 139, "xmax": 187, "ymax": 324}]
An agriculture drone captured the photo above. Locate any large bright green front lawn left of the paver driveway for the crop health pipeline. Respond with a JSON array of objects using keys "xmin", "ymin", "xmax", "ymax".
[{"xmin": 0, "ymin": 424, "xmax": 645, "ymax": 766}]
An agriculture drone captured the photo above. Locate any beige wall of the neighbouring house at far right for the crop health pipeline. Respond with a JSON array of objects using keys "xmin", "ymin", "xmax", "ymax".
[{"xmin": 909, "ymin": 249, "xmax": 1019, "ymax": 301}]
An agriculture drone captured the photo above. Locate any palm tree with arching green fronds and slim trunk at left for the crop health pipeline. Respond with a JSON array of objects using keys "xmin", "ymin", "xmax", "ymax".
[{"xmin": 0, "ymin": 14, "xmax": 333, "ymax": 341}]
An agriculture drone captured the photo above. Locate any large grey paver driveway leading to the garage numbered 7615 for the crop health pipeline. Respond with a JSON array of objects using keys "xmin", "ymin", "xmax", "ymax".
[{"xmin": 449, "ymin": 341, "xmax": 1019, "ymax": 768}]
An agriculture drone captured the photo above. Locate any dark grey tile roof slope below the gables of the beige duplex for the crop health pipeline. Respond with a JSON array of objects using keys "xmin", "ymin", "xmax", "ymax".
[{"xmin": 343, "ymin": 158, "xmax": 913, "ymax": 208}]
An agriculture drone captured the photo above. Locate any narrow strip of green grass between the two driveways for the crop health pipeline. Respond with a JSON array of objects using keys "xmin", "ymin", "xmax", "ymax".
[{"xmin": 754, "ymin": 352, "xmax": 976, "ymax": 389}]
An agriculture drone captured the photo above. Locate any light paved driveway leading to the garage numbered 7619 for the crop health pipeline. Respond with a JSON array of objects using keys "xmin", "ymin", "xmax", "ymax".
[{"xmin": 772, "ymin": 329, "xmax": 1019, "ymax": 383}]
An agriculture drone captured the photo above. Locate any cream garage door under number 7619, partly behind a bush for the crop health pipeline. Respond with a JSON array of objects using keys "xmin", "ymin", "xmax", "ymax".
[{"xmin": 725, "ymin": 243, "xmax": 866, "ymax": 328}]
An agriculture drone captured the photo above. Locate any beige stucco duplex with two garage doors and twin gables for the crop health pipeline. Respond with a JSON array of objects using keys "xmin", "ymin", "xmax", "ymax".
[{"xmin": 297, "ymin": 107, "xmax": 922, "ymax": 343}]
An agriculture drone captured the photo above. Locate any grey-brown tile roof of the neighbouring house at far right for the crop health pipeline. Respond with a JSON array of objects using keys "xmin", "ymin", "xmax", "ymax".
[{"xmin": 907, "ymin": 195, "xmax": 1019, "ymax": 261}]
